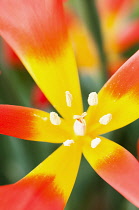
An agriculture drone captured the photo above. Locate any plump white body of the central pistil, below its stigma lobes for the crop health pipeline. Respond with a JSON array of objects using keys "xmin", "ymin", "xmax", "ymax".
[{"xmin": 73, "ymin": 119, "xmax": 86, "ymax": 136}]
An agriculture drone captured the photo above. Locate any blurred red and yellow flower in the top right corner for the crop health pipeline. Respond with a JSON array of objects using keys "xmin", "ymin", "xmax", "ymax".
[{"xmin": 97, "ymin": 0, "xmax": 139, "ymax": 51}]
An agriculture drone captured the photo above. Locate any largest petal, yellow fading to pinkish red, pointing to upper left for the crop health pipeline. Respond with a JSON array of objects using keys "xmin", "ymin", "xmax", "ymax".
[{"xmin": 0, "ymin": 0, "xmax": 82, "ymax": 118}]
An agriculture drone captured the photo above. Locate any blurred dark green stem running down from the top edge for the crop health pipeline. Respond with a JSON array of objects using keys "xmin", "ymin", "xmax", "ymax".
[{"xmin": 75, "ymin": 0, "xmax": 108, "ymax": 83}]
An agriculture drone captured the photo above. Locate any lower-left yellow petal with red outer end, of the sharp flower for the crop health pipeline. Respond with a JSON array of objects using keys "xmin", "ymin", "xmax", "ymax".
[{"xmin": 0, "ymin": 144, "xmax": 81, "ymax": 210}]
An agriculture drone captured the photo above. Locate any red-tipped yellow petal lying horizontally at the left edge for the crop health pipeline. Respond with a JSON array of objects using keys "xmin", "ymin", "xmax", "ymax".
[{"xmin": 0, "ymin": 105, "xmax": 71, "ymax": 143}]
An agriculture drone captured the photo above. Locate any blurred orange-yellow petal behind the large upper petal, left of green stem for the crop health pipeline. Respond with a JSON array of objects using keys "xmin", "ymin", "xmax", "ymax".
[{"xmin": 67, "ymin": 11, "xmax": 99, "ymax": 72}]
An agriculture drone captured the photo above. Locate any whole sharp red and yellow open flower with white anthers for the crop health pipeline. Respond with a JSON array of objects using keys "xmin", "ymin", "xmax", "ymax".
[{"xmin": 0, "ymin": 0, "xmax": 139, "ymax": 210}]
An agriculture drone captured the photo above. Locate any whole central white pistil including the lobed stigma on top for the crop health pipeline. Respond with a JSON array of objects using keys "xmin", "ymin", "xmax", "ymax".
[{"xmin": 73, "ymin": 112, "xmax": 87, "ymax": 136}]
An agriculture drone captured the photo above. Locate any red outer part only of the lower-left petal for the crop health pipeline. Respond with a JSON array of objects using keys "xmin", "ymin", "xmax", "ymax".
[{"xmin": 0, "ymin": 176, "xmax": 65, "ymax": 210}]
